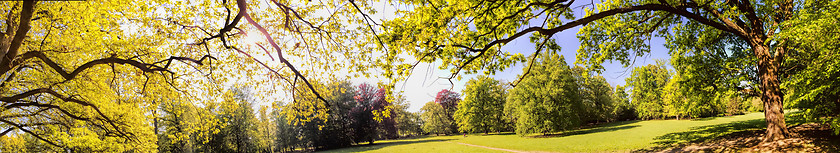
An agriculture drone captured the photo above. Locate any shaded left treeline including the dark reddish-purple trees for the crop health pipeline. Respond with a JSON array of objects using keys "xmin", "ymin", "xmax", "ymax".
[{"xmin": 156, "ymin": 81, "xmax": 422, "ymax": 152}]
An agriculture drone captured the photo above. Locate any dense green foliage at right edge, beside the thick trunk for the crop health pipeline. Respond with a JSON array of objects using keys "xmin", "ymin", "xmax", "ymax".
[{"xmin": 776, "ymin": 1, "xmax": 840, "ymax": 135}]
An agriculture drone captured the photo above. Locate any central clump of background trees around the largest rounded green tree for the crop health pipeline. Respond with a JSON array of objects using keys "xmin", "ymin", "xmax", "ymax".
[{"xmin": 440, "ymin": 54, "xmax": 635, "ymax": 135}]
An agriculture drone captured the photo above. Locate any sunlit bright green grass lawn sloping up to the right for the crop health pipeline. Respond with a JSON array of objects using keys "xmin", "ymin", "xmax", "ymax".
[{"xmin": 326, "ymin": 113, "xmax": 801, "ymax": 153}]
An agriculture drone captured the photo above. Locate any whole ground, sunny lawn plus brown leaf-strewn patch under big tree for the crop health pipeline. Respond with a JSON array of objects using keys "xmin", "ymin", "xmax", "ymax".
[{"xmin": 316, "ymin": 113, "xmax": 840, "ymax": 153}]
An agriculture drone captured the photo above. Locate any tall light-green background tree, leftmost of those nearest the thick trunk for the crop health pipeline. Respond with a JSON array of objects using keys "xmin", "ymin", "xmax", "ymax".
[{"xmin": 627, "ymin": 61, "xmax": 671, "ymax": 119}]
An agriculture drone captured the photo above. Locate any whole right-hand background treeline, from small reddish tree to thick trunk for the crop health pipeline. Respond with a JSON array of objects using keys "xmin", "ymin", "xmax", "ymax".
[{"xmin": 430, "ymin": 53, "xmax": 762, "ymax": 135}]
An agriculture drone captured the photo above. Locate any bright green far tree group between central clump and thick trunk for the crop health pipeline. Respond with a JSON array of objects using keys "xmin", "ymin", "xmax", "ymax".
[{"xmin": 627, "ymin": 60, "xmax": 763, "ymax": 119}]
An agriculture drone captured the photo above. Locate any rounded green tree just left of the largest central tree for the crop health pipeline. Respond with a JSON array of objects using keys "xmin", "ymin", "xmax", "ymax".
[{"xmin": 454, "ymin": 75, "xmax": 508, "ymax": 134}]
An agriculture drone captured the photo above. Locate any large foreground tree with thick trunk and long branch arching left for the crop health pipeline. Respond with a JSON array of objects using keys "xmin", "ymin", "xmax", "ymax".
[{"xmin": 379, "ymin": 0, "xmax": 808, "ymax": 141}]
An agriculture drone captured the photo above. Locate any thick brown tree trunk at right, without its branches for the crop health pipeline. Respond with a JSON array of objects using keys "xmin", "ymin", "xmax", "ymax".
[{"xmin": 754, "ymin": 43, "xmax": 788, "ymax": 142}]
